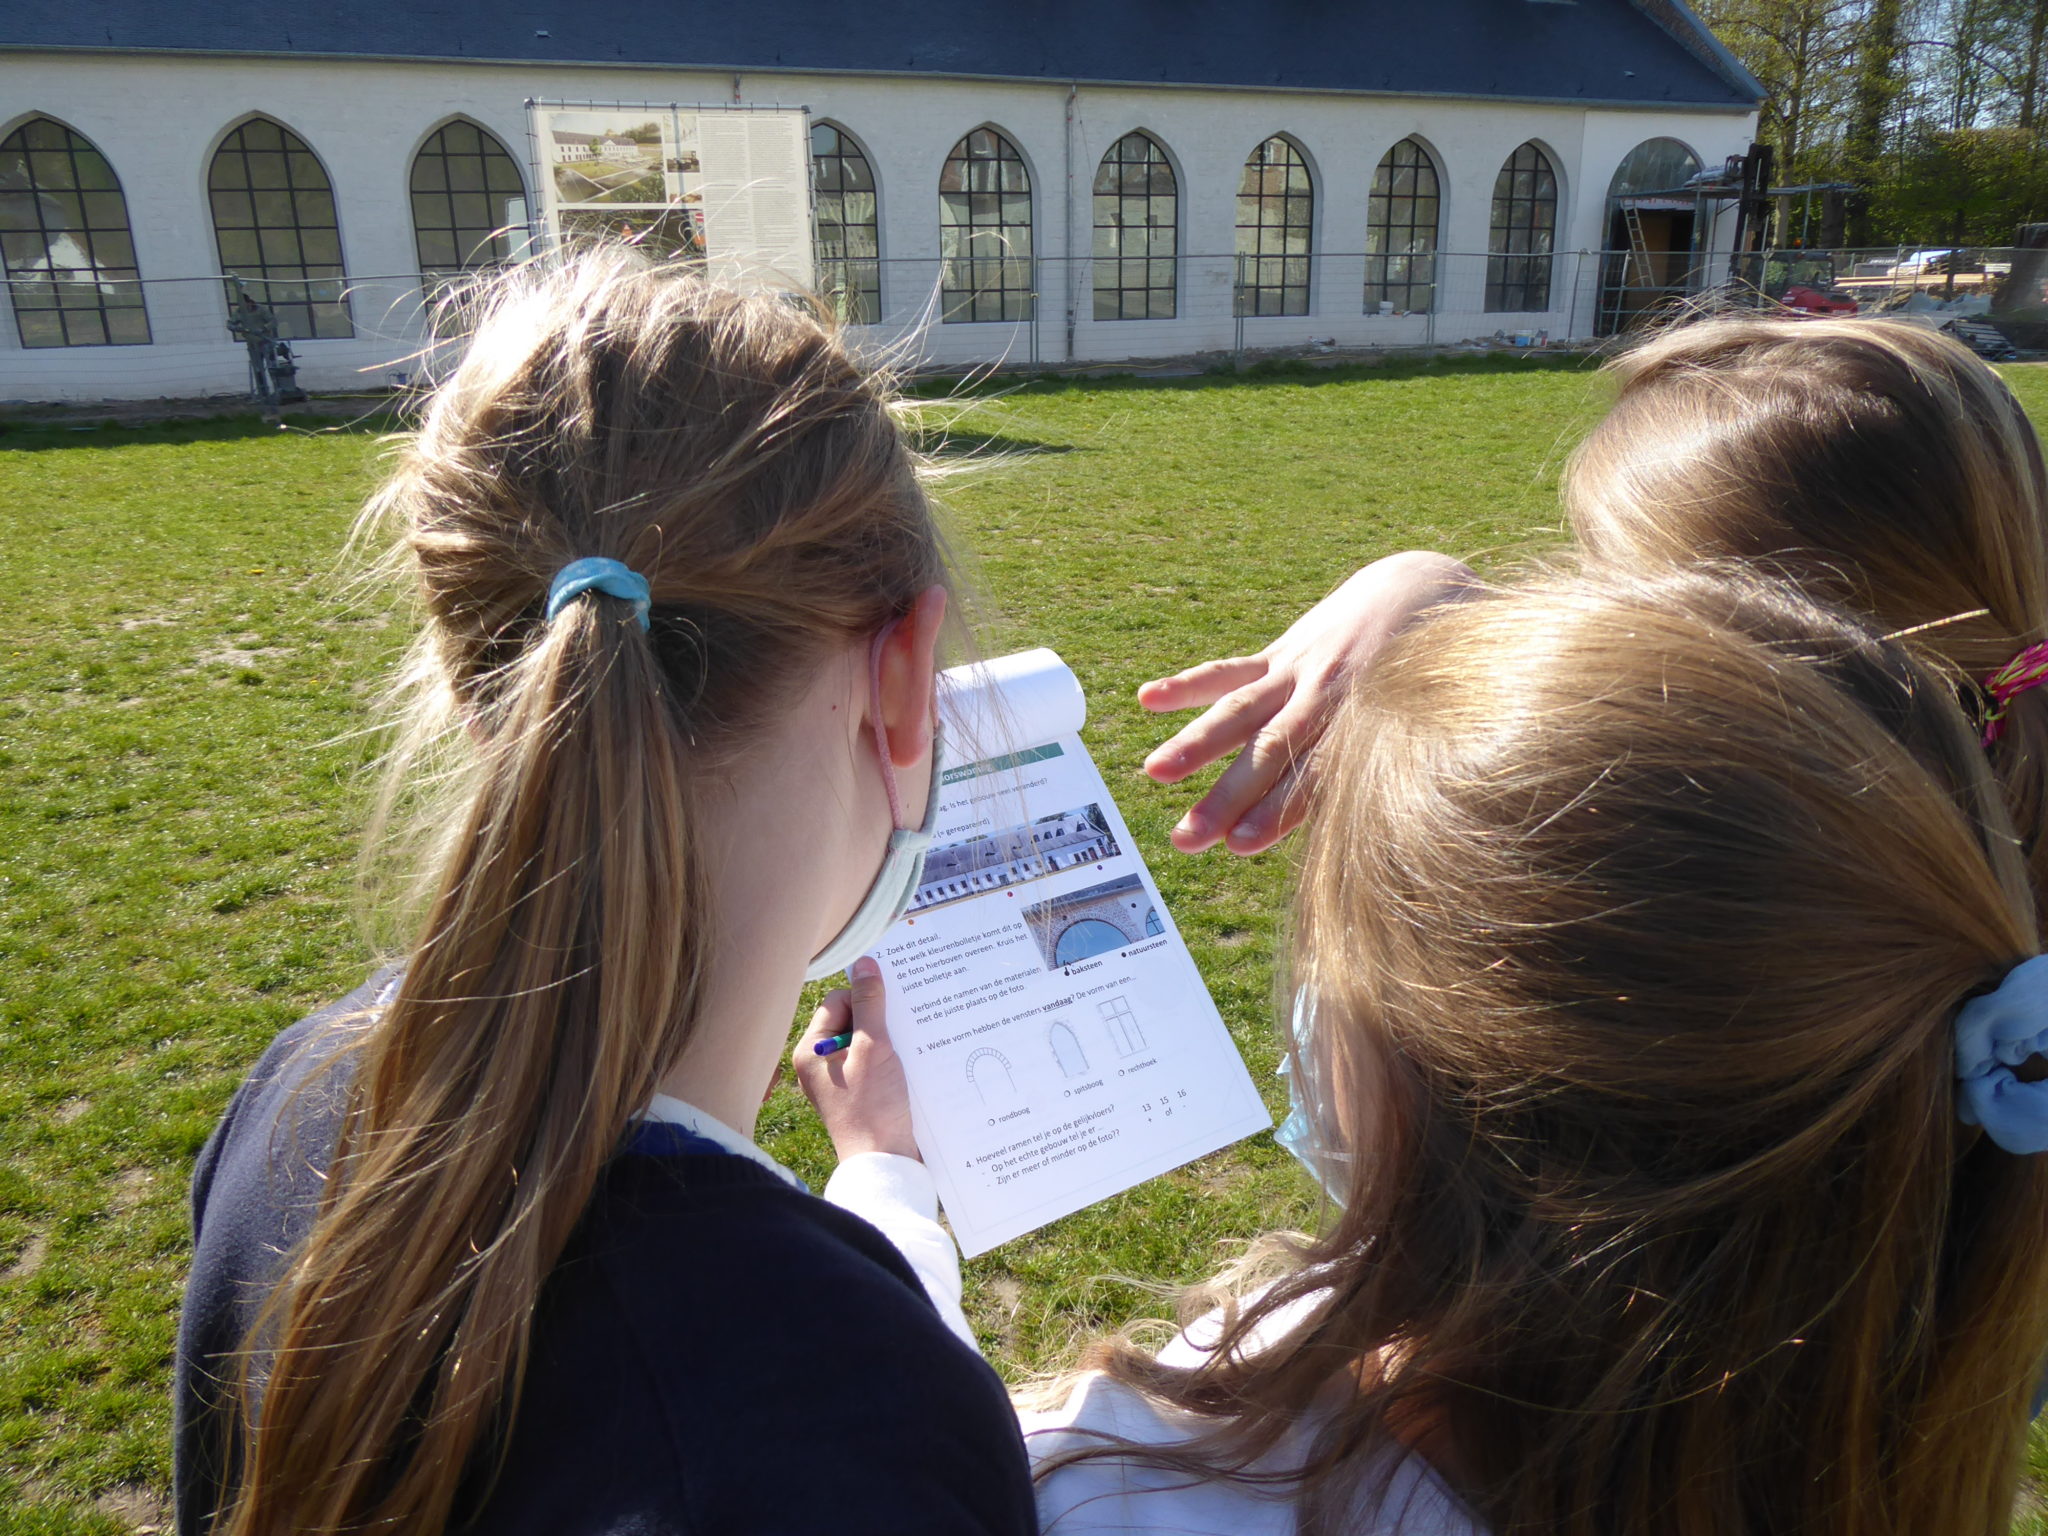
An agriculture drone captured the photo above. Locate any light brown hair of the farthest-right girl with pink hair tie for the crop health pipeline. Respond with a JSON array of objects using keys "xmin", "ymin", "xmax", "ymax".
[{"xmin": 1563, "ymin": 317, "xmax": 2048, "ymax": 913}]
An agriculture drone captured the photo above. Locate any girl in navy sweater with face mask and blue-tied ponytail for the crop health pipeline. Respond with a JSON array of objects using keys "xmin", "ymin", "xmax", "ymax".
[{"xmin": 178, "ymin": 258, "xmax": 1032, "ymax": 1536}]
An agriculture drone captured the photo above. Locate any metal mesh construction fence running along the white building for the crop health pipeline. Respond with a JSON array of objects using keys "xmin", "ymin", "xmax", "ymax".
[{"xmin": 0, "ymin": 250, "xmax": 2048, "ymax": 401}]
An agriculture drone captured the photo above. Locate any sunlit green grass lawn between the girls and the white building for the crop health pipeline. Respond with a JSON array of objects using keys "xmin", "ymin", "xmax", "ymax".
[{"xmin": 12, "ymin": 354, "xmax": 2048, "ymax": 1536}]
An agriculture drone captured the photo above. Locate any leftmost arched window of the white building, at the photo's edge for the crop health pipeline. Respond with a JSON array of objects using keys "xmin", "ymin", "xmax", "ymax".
[{"xmin": 0, "ymin": 117, "xmax": 150, "ymax": 346}]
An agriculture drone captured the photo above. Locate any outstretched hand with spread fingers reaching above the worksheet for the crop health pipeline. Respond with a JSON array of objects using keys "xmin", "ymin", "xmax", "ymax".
[{"xmin": 1139, "ymin": 551, "xmax": 1479, "ymax": 854}]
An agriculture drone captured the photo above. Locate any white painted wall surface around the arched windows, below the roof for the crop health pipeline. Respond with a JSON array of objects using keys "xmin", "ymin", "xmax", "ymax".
[{"xmin": 0, "ymin": 51, "xmax": 1755, "ymax": 399}]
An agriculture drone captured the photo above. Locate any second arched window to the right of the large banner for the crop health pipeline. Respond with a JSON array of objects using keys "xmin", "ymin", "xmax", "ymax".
[{"xmin": 938, "ymin": 129, "xmax": 1034, "ymax": 319}]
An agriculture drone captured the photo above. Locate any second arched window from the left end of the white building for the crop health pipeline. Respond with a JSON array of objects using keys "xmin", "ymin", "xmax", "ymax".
[{"xmin": 207, "ymin": 117, "xmax": 356, "ymax": 340}]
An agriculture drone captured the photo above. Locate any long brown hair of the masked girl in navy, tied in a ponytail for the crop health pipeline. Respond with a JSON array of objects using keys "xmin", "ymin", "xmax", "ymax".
[{"xmin": 217, "ymin": 258, "xmax": 944, "ymax": 1536}]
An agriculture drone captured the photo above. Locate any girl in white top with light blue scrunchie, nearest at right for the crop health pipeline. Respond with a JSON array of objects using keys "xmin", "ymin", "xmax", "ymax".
[{"xmin": 1026, "ymin": 569, "xmax": 2048, "ymax": 1536}]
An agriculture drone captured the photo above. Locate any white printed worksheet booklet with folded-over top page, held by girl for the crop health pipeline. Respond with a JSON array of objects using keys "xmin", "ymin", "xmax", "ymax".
[{"xmin": 874, "ymin": 649, "xmax": 1272, "ymax": 1257}]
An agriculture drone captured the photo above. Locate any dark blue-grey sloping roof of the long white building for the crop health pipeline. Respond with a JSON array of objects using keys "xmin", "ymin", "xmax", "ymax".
[{"xmin": 0, "ymin": 0, "xmax": 1761, "ymax": 109}]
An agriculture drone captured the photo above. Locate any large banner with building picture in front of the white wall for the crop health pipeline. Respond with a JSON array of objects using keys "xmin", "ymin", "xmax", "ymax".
[{"xmin": 532, "ymin": 100, "xmax": 813, "ymax": 293}]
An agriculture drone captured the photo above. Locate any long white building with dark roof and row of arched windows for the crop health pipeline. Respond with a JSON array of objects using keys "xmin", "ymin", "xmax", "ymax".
[{"xmin": 0, "ymin": 0, "xmax": 1759, "ymax": 399}]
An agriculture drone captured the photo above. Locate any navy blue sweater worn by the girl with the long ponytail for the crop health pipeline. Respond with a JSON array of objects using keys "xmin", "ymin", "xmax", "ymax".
[{"xmin": 176, "ymin": 979, "xmax": 1036, "ymax": 1536}]
